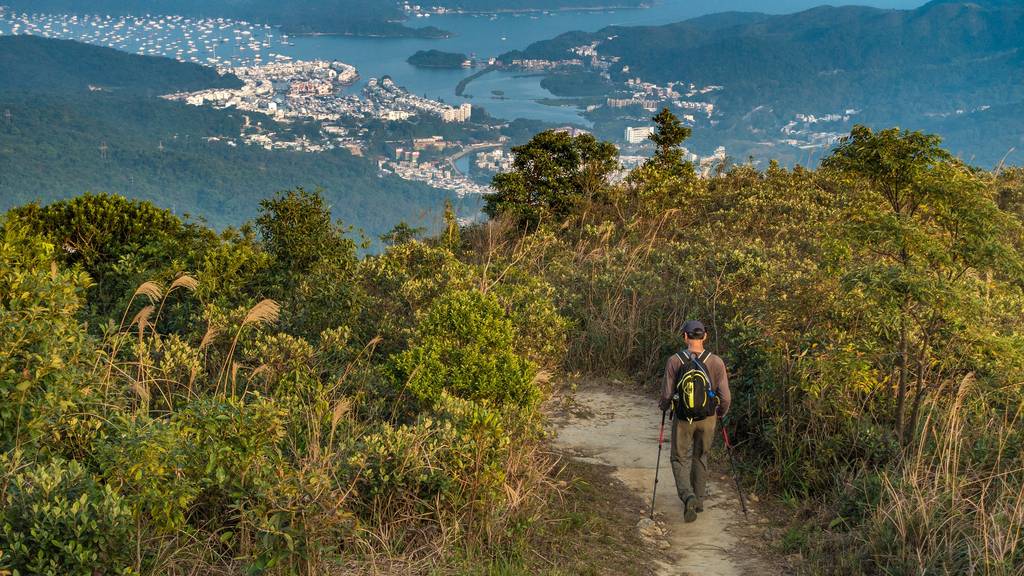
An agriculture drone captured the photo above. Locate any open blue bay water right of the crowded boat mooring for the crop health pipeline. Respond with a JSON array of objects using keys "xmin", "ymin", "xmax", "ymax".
[{"xmin": 278, "ymin": 0, "xmax": 923, "ymax": 125}]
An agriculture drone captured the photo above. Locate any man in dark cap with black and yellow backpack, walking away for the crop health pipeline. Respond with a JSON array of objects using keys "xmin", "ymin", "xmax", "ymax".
[{"xmin": 658, "ymin": 320, "xmax": 732, "ymax": 522}]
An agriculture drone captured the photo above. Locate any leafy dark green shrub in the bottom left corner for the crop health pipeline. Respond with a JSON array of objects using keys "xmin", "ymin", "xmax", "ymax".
[{"xmin": 0, "ymin": 460, "xmax": 137, "ymax": 576}]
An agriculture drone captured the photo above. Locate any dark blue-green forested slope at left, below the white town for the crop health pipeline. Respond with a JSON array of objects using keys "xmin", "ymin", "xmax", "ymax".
[{"xmin": 0, "ymin": 37, "xmax": 456, "ymax": 238}]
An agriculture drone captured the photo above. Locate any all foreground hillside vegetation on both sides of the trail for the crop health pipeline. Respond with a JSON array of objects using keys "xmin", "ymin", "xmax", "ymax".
[{"xmin": 0, "ymin": 112, "xmax": 1024, "ymax": 576}]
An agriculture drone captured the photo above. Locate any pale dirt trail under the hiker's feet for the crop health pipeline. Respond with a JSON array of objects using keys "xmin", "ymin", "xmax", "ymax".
[{"xmin": 553, "ymin": 387, "xmax": 784, "ymax": 576}]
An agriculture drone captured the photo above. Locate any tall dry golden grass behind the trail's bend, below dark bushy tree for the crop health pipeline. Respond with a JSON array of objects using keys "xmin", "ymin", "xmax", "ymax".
[{"xmin": 465, "ymin": 209, "xmax": 700, "ymax": 376}]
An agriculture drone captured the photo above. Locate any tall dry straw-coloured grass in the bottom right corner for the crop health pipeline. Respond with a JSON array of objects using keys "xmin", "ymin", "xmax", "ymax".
[{"xmin": 865, "ymin": 376, "xmax": 1024, "ymax": 576}]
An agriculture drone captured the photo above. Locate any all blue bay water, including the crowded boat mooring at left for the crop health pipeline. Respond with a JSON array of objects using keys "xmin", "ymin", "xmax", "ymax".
[{"xmin": 0, "ymin": 0, "xmax": 923, "ymax": 125}]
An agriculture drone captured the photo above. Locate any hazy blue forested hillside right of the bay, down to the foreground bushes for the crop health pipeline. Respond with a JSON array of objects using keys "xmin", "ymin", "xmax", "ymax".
[{"xmin": 504, "ymin": 0, "xmax": 1024, "ymax": 166}]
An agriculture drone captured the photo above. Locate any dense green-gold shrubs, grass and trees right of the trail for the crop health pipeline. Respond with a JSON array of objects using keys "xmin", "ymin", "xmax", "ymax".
[{"xmin": 477, "ymin": 111, "xmax": 1024, "ymax": 575}]
